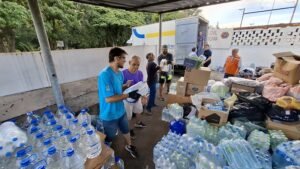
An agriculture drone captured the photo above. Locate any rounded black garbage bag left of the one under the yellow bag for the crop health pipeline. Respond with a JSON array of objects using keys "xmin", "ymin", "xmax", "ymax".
[{"xmin": 228, "ymin": 102, "xmax": 265, "ymax": 121}]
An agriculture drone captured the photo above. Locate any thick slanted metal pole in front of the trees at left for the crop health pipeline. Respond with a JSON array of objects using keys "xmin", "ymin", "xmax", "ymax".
[{"xmin": 28, "ymin": 0, "xmax": 64, "ymax": 106}]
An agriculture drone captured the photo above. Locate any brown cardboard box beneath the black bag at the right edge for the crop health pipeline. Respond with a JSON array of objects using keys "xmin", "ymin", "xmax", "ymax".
[{"xmin": 266, "ymin": 118, "xmax": 300, "ymax": 140}]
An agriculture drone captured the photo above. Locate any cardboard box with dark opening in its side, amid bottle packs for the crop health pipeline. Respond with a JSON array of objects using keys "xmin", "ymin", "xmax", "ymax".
[{"xmin": 198, "ymin": 99, "xmax": 230, "ymax": 126}]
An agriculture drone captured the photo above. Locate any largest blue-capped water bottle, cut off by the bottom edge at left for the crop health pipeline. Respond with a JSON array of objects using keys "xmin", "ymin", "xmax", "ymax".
[{"xmin": 62, "ymin": 148, "xmax": 84, "ymax": 169}]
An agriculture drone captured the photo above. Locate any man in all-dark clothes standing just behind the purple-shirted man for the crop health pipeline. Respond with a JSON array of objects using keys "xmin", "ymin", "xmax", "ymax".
[{"xmin": 146, "ymin": 53, "xmax": 160, "ymax": 115}]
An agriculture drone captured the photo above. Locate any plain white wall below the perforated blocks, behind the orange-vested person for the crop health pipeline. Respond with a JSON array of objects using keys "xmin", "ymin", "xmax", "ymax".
[{"xmin": 211, "ymin": 46, "xmax": 300, "ymax": 68}]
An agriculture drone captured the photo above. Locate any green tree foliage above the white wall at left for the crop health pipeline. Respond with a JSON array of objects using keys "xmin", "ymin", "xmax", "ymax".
[{"xmin": 0, "ymin": 0, "xmax": 203, "ymax": 52}]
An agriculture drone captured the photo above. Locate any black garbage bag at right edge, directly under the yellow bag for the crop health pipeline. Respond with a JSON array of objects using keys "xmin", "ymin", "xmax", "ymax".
[{"xmin": 267, "ymin": 104, "xmax": 300, "ymax": 122}]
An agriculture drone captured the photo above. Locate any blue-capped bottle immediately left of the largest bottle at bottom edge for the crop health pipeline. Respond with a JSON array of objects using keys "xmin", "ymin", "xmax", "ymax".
[{"xmin": 46, "ymin": 146, "xmax": 63, "ymax": 169}]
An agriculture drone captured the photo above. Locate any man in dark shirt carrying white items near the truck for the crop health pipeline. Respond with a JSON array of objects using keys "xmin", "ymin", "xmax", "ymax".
[{"xmin": 158, "ymin": 45, "xmax": 173, "ymax": 101}]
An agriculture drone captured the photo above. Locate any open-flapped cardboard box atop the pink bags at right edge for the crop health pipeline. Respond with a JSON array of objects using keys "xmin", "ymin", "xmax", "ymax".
[{"xmin": 273, "ymin": 52, "xmax": 300, "ymax": 85}]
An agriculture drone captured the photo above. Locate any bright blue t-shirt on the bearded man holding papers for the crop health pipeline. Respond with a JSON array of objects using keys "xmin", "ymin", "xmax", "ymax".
[{"xmin": 98, "ymin": 66, "xmax": 125, "ymax": 121}]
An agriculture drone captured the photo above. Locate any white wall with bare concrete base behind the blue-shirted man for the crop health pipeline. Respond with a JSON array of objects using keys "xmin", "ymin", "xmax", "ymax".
[{"xmin": 0, "ymin": 46, "xmax": 157, "ymax": 121}]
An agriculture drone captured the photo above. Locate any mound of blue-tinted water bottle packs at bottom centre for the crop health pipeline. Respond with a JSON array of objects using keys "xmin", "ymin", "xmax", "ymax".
[{"xmin": 153, "ymin": 132, "xmax": 225, "ymax": 169}]
